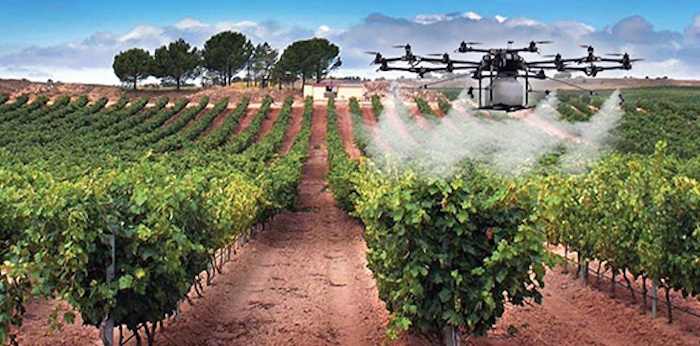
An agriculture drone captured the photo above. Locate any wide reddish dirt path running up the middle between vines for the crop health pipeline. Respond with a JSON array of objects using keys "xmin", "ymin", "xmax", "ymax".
[{"xmin": 157, "ymin": 107, "xmax": 388, "ymax": 346}]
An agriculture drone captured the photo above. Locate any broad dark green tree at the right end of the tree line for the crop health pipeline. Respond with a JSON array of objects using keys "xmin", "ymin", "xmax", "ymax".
[{"xmin": 279, "ymin": 38, "xmax": 341, "ymax": 88}]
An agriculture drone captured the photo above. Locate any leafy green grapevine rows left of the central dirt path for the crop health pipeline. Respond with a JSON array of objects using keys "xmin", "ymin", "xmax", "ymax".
[{"xmin": 0, "ymin": 96, "xmax": 312, "ymax": 344}]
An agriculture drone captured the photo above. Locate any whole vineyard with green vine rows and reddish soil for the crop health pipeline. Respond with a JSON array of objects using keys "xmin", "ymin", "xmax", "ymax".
[{"xmin": 0, "ymin": 84, "xmax": 700, "ymax": 345}]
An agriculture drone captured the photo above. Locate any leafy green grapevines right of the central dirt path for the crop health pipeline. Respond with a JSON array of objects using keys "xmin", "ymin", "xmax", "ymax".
[{"xmin": 328, "ymin": 94, "xmax": 700, "ymax": 344}]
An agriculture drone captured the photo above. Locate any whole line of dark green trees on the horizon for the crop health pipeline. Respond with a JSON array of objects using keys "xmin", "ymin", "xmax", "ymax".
[{"xmin": 112, "ymin": 31, "xmax": 341, "ymax": 90}]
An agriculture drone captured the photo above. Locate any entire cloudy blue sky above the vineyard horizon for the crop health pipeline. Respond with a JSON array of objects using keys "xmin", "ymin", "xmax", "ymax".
[{"xmin": 0, "ymin": 0, "xmax": 700, "ymax": 84}]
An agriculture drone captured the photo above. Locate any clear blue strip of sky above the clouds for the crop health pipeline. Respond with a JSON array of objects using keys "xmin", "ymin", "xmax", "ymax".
[{"xmin": 0, "ymin": 0, "xmax": 700, "ymax": 47}]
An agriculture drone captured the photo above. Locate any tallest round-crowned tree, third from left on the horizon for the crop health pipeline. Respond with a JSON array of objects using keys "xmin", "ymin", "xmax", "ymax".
[{"xmin": 202, "ymin": 31, "xmax": 250, "ymax": 85}]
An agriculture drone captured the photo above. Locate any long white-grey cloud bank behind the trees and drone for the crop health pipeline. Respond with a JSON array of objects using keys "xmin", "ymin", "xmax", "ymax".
[{"xmin": 0, "ymin": 11, "xmax": 700, "ymax": 84}]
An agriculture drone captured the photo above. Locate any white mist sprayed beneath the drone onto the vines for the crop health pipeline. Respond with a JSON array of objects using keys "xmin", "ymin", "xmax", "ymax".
[{"xmin": 368, "ymin": 86, "xmax": 622, "ymax": 177}]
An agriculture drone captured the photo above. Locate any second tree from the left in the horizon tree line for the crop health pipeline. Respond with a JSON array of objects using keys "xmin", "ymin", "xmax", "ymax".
[{"xmin": 153, "ymin": 39, "xmax": 201, "ymax": 90}]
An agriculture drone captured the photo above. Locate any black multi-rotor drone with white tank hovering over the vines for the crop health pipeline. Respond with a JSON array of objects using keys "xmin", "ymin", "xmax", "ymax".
[{"xmin": 366, "ymin": 41, "xmax": 643, "ymax": 112}]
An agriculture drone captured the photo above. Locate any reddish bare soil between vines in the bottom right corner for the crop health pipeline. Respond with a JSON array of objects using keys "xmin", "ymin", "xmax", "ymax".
[{"xmin": 476, "ymin": 267, "xmax": 700, "ymax": 346}]
